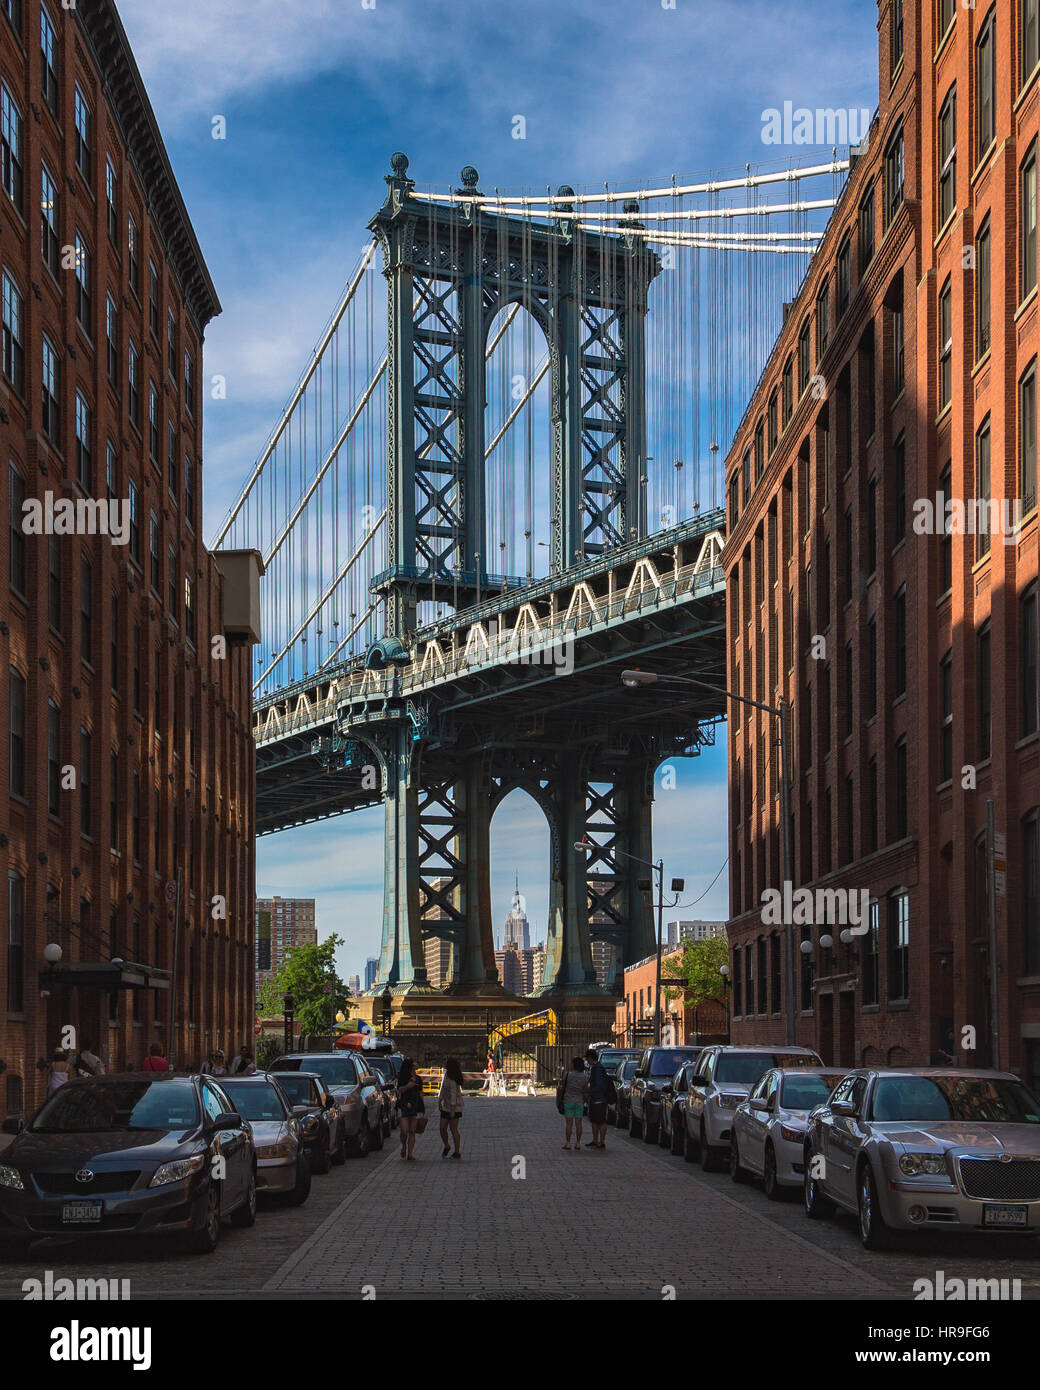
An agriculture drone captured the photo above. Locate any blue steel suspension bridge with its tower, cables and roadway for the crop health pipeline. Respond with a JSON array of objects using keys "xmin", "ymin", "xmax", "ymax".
[{"xmin": 213, "ymin": 152, "xmax": 848, "ymax": 995}]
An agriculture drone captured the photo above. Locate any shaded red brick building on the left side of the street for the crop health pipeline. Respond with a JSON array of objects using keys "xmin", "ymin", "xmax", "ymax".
[{"xmin": 0, "ymin": 0, "xmax": 254, "ymax": 1113}]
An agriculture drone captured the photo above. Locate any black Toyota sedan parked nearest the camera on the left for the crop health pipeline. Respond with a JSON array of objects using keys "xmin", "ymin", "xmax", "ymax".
[{"xmin": 0, "ymin": 1072, "xmax": 256, "ymax": 1254}]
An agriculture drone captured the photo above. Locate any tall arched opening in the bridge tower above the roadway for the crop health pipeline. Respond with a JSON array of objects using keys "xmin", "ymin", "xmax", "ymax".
[{"xmin": 482, "ymin": 303, "xmax": 553, "ymax": 580}]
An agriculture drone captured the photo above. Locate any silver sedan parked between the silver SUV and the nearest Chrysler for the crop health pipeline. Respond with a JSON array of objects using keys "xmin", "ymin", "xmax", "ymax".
[{"xmin": 730, "ymin": 1066, "xmax": 844, "ymax": 1201}]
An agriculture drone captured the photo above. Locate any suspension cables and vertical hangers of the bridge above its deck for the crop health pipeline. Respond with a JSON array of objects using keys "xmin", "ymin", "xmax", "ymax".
[{"xmin": 211, "ymin": 152, "xmax": 848, "ymax": 698}]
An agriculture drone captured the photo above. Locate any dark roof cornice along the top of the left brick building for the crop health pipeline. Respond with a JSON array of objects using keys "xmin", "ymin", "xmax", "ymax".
[{"xmin": 72, "ymin": 0, "xmax": 221, "ymax": 334}]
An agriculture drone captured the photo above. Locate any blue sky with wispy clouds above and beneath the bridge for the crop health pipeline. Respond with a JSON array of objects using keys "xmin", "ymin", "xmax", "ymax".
[{"xmin": 118, "ymin": 0, "xmax": 877, "ymax": 973}]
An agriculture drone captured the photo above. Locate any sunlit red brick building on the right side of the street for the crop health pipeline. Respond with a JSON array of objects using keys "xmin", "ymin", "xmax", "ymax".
[{"xmin": 726, "ymin": 0, "xmax": 1040, "ymax": 1084}]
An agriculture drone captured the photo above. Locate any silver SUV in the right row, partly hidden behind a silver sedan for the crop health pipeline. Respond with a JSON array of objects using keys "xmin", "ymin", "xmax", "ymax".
[{"xmin": 685, "ymin": 1044, "xmax": 823, "ymax": 1173}]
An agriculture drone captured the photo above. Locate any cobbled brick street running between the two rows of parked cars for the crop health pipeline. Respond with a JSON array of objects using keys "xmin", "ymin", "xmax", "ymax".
[{"xmin": 0, "ymin": 1097, "xmax": 1040, "ymax": 1300}]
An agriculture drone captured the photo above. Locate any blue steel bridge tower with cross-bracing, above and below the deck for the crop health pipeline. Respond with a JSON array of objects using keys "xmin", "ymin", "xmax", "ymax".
[{"xmin": 368, "ymin": 154, "xmax": 660, "ymax": 995}]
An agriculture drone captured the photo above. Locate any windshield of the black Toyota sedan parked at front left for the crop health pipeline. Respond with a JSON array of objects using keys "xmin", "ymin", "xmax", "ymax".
[{"xmin": 29, "ymin": 1080, "xmax": 199, "ymax": 1134}]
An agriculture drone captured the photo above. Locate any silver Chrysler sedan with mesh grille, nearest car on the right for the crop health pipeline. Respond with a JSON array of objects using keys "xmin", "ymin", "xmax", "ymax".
[{"xmin": 802, "ymin": 1066, "xmax": 1040, "ymax": 1250}]
